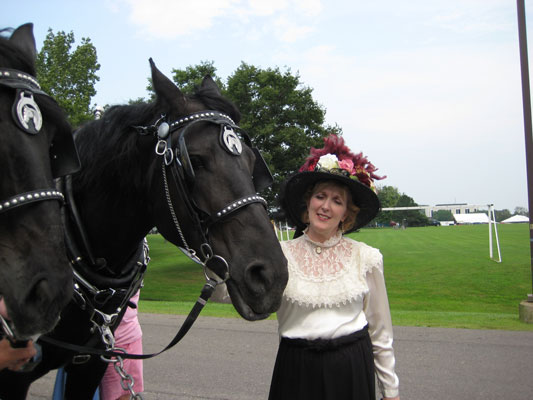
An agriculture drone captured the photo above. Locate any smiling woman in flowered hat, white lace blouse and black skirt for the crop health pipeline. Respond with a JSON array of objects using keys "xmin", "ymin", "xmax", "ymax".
[{"xmin": 269, "ymin": 135, "xmax": 399, "ymax": 400}]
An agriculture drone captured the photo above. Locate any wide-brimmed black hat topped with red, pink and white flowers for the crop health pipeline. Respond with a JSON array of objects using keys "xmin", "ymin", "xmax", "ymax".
[{"xmin": 280, "ymin": 135, "xmax": 385, "ymax": 233}]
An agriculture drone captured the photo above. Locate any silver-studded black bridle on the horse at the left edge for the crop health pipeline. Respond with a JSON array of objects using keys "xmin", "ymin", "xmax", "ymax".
[{"xmin": 0, "ymin": 68, "xmax": 80, "ymax": 214}]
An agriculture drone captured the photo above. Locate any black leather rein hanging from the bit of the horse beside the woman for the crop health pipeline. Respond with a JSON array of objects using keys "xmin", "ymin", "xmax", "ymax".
[{"xmin": 37, "ymin": 280, "xmax": 217, "ymax": 360}]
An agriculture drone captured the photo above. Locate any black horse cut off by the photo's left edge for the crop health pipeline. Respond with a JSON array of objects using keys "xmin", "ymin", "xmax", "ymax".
[{"xmin": 0, "ymin": 24, "xmax": 79, "ymax": 340}]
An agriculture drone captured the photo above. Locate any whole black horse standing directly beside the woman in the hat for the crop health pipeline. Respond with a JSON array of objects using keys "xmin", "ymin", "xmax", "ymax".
[{"xmin": 0, "ymin": 60, "xmax": 287, "ymax": 399}]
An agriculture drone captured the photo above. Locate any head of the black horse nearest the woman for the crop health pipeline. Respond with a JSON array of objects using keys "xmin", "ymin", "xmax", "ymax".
[{"xmin": 145, "ymin": 60, "xmax": 288, "ymax": 320}]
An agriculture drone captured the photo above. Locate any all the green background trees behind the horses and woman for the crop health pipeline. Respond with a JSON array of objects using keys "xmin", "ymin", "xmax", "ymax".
[{"xmin": 36, "ymin": 29, "xmax": 527, "ymax": 226}]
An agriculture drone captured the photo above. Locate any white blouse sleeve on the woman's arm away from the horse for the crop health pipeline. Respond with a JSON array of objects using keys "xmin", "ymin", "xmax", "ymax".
[{"xmin": 363, "ymin": 249, "xmax": 399, "ymax": 397}]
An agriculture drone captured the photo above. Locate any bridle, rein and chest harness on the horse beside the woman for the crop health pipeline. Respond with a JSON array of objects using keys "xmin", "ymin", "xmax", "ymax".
[{"xmin": 39, "ymin": 111, "xmax": 272, "ymax": 363}]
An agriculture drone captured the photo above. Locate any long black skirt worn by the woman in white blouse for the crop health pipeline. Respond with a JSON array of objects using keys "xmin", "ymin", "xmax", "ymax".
[{"xmin": 268, "ymin": 327, "xmax": 376, "ymax": 400}]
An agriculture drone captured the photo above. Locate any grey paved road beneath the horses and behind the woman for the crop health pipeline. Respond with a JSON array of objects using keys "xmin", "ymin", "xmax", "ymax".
[{"xmin": 29, "ymin": 314, "xmax": 533, "ymax": 400}]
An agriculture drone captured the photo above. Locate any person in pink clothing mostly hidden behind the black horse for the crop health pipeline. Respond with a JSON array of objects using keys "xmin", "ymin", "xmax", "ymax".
[{"xmin": 100, "ymin": 291, "xmax": 144, "ymax": 400}]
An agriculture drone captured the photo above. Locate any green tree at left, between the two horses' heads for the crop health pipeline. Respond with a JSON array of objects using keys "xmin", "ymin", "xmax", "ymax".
[{"xmin": 36, "ymin": 29, "xmax": 100, "ymax": 127}]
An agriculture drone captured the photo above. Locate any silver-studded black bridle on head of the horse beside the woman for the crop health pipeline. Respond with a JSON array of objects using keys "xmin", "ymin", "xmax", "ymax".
[{"xmin": 135, "ymin": 111, "xmax": 272, "ymax": 283}]
